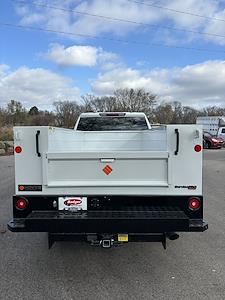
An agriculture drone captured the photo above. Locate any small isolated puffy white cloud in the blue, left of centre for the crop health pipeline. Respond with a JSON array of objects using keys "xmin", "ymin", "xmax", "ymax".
[{"xmin": 44, "ymin": 44, "xmax": 117, "ymax": 67}]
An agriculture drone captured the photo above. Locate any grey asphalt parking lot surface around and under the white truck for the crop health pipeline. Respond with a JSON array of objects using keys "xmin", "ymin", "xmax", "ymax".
[{"xmin": 0, "ymin": 150, "xmax": 225, "ymax": 300}]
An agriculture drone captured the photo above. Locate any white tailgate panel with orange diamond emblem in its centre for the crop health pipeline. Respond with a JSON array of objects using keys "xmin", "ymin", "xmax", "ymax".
[{"xmin": 43, "ymin": 151, "xmax": 169, "ymax": 187}]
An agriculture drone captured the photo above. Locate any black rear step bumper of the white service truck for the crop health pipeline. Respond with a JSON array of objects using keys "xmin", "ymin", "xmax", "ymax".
[{"xmin": 8, "ymin": 210, "xmax": 208, "ymax": 234}]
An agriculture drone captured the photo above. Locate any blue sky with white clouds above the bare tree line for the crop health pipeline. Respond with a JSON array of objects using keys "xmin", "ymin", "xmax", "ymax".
[{"xmin": 0, "ymin": 0, "xmax": 225, "ymax": 109}]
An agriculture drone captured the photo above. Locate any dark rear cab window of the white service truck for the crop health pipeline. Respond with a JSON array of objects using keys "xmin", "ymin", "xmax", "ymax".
[{"xmin": 77, "ymin": 117, "xmax": 148, "ymax": 131}]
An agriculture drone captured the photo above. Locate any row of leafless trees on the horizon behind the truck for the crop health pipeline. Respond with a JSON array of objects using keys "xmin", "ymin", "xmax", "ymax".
[{"xmin": 0, "ymin": 93, "xmax": 225, "ymax": 130}]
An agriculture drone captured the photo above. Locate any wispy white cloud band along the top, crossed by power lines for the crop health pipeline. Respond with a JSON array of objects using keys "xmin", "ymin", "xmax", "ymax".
[{"xmin": 14, "ymin": 0, "xmax": 225, "ymax": 45}]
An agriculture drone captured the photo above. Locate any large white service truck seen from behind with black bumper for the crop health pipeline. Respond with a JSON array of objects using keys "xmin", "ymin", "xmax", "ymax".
[{"xmin": 8, "ymin": 112, "xmax": 208, "ymax": 248}]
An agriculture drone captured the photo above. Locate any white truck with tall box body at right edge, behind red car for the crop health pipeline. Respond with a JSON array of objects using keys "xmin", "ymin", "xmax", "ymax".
[{"xmin": 196, "ymin": 116, "xmax": 225, "ymax": 138}]
